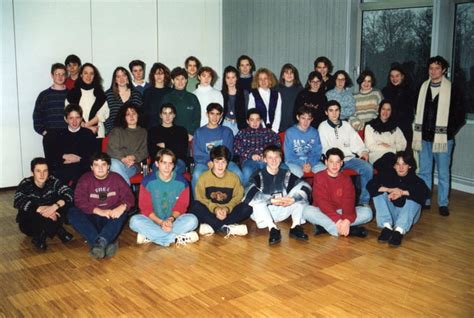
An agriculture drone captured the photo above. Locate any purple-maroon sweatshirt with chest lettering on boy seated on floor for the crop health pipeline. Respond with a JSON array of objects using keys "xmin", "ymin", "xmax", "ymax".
[{"xmin": 74, "ymin": 171, "xmax": 135, "ymax": 214}]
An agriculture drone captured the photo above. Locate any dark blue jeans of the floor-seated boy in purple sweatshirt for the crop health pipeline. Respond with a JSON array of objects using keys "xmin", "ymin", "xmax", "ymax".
[{"xmin": 68, "ymin": 207, "xmax": 127, "ymax": 247}]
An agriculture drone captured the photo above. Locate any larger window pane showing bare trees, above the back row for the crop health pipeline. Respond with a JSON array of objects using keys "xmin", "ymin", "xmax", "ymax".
[{"xmin": 361, "ymin": 7, "xmax": 432, "ymax": 88}]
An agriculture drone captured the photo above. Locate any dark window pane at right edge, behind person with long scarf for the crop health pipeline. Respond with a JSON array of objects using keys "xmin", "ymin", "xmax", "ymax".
[{"xmin": 453, "ymin": 3, "xmax": 474, "ymax": 113}]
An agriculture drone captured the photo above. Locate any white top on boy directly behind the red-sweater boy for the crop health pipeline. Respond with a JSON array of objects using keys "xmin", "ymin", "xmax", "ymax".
[{"xmin": 318, "ymin": 120, "xmax": 368, "ymax": 161}]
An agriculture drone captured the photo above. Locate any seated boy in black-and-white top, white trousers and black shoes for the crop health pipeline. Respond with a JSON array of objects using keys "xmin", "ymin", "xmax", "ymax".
[{"xmin": 245, "ymin": 145, "xmax": 311, "ymax": 245}]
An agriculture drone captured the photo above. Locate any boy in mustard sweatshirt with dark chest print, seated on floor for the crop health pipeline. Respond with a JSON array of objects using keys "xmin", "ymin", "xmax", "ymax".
[{"xmin": 190, "ymin": 145, "xmax": 252, "ymax": 236}]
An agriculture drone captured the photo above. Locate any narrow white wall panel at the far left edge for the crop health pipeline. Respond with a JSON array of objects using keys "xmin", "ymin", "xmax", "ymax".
[{"xmin": 0, "ymin": 1, "xmax": 22, "ymax": 188}]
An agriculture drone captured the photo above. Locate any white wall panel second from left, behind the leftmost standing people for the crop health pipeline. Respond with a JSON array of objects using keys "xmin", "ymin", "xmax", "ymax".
[{"xmin": 14, "ymin": 0, "xmax": 91, "ymax": 183}]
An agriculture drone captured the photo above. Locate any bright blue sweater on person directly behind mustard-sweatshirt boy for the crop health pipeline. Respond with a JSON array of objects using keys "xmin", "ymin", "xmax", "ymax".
[{"xmin": 193, "ymin": 125, "xmax": 234, "ymax": 165}]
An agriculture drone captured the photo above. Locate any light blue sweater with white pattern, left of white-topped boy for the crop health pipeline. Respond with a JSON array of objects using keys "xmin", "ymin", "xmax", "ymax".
[{"xmin": 285, "ymin": 125, "xmax": 322, "ymax": 166}]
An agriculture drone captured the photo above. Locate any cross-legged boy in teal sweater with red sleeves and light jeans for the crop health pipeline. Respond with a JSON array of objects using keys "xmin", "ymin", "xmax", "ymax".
[{"xmin": 130, "ymin": 148, "xmax": 199, "ymax": 246}]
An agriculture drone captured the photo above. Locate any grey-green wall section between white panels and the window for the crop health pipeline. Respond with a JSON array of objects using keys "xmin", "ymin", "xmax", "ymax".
[{"xmin": 223, "ymin": 0, "xmax": 348, "ymax": 81}]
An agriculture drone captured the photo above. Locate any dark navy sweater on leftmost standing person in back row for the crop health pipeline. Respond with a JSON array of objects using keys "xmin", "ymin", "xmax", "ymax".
[{"xmin": 33, "ymin": 87, "xmax": 68, "ymax": 135}]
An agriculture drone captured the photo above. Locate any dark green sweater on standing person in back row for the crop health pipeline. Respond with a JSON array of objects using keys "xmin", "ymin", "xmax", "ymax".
[{"xmin": 161, "ymin": 89, "xmax": 201, "ymax": 135}]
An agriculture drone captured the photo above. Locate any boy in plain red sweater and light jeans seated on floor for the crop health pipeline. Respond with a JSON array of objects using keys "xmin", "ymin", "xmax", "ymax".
[{"xmin": 303, "ymin": 148, "xmax": 372, "ymax": 237}]
